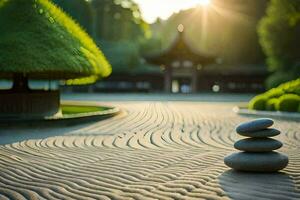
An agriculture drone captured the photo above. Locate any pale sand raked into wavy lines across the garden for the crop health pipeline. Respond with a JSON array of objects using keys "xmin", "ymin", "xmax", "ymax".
[{"xmin": 0, "ymin": 102, "xmax": 300, "ymax": 200}]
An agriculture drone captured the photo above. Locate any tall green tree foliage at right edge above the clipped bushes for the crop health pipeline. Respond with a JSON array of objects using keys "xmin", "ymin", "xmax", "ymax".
[{"xmin": 258, "ymin": 0, "xmax": 300, "ymax": 75}]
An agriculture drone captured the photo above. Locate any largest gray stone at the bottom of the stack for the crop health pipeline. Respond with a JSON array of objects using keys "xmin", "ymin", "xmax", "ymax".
[{"xmin": 224, "ymin": 152, "xmax": 289, "ymax": 172}]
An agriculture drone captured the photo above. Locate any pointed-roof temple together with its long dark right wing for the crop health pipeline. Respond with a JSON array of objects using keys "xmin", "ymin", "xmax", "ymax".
[{"xmin": 144, "ymin": 24, "xmax": 269, "ymax": 93}]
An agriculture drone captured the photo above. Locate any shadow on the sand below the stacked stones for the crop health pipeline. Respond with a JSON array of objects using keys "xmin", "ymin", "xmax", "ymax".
[{"xmin": 218, "ymin": 170, "xmax": 300, "ymax": 200}]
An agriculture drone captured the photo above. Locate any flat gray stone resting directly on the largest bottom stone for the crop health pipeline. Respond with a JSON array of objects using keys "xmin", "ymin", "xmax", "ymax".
[{"xmin": 234, "ymin": 138, "xmax": 283, "ymax": 152}]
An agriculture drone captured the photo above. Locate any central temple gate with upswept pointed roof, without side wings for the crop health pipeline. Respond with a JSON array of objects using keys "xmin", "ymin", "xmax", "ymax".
[{"xmin": 145, "ymin": 24, "xmax": 216, "ymax": 93}]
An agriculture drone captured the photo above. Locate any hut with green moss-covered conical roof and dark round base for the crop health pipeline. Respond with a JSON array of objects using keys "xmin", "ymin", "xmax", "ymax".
[{"xmin": 0, "ymin": 0, "xmax": 111, "ymax": 117}]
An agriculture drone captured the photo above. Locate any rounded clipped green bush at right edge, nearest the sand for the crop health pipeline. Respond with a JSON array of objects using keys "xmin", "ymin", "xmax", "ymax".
[{"xmin": 275, "ymin": 94, "xmax": 300, "ymax": 112}]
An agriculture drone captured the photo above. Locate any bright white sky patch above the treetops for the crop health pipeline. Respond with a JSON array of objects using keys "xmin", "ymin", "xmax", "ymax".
[{"xmin": 133, "ymin": 0, "xmax": 210, "ymax": 23}]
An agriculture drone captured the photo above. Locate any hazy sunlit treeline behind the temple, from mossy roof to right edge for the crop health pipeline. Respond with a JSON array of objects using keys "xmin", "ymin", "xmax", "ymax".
[{"xmin": 53, "ymin": 0, "xmax": 300, "ymax": 87}]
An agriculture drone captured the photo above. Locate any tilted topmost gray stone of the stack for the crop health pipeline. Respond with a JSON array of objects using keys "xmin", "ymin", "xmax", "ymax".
[{"xmin": 236, "ymin": 118, "xmax": 274, "ymax": 134}]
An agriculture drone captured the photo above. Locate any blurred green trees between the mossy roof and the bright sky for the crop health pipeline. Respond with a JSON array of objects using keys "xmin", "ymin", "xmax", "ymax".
[{"xmin": 91, "ymin": 0, "xmax": 150, "ymax": 74}]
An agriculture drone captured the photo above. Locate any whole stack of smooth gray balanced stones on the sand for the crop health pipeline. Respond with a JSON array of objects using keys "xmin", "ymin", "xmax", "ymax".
[{"xmin": 224, "ymin": 118, "xmax": 289, "ymax": 172}]
